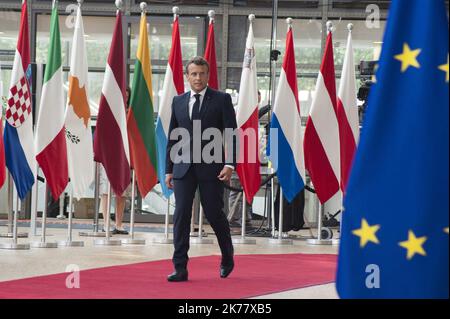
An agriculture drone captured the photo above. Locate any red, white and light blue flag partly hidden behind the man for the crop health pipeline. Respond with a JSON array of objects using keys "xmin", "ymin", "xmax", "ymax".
[{"xmin": 156, "ymin": 14, "xmax": 184, "ymax": 198}]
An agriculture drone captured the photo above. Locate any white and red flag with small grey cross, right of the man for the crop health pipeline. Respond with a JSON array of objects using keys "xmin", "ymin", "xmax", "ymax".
[{"xmin": 236, "ymin": 14, "xmax": 261, "ymax": 203}]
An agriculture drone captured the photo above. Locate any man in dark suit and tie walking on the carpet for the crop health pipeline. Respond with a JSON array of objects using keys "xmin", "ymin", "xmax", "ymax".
[{"xmin": 165, "ymin": 57, "xmax": 237, "ymax": 281}]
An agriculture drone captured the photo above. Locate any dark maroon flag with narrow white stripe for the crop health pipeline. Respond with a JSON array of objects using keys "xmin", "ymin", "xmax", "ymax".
[{"xmin": 94, "ymin": 6, "xmax": 131, "ymax": 196}]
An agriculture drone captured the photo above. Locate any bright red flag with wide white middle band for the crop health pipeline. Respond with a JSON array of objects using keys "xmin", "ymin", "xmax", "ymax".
[{"xmin": 304, "ymin": 22, "xmax": 341, "ymax": 204}]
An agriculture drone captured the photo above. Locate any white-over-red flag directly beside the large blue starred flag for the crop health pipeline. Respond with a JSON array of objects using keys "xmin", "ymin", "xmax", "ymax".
[{"xmin": 337, "ymin": 24, "xmax": 359, "ymax": 192}]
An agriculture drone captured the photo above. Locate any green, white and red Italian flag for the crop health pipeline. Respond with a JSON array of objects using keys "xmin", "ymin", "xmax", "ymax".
[{"xmin": 35, "ymin": 1, "xmax": 69, "ymax": 200}]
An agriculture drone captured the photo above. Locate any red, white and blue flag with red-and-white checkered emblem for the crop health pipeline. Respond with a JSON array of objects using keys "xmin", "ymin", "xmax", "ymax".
[{"xmin": 4, "ymin": 1, "xmax": 36, "ymax": 199}]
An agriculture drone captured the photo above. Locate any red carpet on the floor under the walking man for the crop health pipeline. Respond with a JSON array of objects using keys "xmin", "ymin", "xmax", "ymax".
[{"xmin": 0, "ymin": 254, "xmax": 337, "ymax": 299}]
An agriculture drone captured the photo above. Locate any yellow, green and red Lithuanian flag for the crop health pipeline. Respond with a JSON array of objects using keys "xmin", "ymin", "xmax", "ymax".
[{"xmin": 127, "ymin": 12, "xmax": 157, "ymax": 198}]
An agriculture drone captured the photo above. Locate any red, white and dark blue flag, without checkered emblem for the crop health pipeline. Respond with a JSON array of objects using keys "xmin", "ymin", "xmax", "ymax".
[{"xmin": 270, "ymin": 19, "xmax": 305, "ymax": 202}]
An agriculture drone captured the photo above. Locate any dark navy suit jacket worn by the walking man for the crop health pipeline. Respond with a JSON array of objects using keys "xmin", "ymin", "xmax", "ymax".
[{"xmin": 166, "ymin": 87, "xmax": 237, "ymax": 180}]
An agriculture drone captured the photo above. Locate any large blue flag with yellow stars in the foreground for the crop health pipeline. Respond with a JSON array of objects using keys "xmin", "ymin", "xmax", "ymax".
[{"xmin": 336, "ymin": 0, "xmax": 449, "ymax": 298}]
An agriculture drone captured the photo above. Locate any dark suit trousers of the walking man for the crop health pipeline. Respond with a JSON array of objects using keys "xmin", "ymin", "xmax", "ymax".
[{"xmin": 172, "ymin": 164, "xmax": 234, "ymax": 269}]
